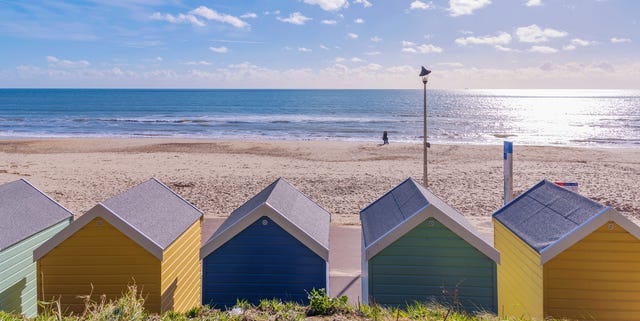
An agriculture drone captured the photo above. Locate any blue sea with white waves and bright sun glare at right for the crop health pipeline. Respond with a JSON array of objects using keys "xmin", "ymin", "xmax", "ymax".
[{"xmin": 0, "ymin": 89, "xmax": 640, "ymax": 147}]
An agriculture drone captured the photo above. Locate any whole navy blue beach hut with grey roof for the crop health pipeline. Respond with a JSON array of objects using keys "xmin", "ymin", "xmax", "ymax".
[{"xmin": 200, "ymin": 178, "xmax": 330, "ymax": 308}]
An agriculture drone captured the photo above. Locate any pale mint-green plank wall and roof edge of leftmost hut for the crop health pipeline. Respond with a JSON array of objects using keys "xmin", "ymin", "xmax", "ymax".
[{"xmin": 0, "ymin": 219, "xmax": 71, "ymax": 317}]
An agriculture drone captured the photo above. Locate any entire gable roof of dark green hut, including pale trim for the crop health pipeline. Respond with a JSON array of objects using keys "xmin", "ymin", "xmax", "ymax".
[{"xmin": 360, "ymin": 178, "xmax": 500, "ymax": 262}]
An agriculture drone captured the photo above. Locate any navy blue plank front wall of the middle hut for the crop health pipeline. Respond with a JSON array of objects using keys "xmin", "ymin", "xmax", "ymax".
[{"xmin": 202, "ymin": 216, "xmax": 327, "ymax": 308}]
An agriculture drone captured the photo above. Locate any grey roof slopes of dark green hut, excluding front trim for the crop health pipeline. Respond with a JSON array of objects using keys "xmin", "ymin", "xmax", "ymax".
[{"xmin": 360, "ymin": 178, "xmax": 482, "ymax": 247}]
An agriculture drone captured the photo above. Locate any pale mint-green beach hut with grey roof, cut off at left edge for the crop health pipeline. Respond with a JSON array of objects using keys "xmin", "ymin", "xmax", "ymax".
[{"xmin": 0, "ymin": 179, "xmax": 73, "ymax": 317}]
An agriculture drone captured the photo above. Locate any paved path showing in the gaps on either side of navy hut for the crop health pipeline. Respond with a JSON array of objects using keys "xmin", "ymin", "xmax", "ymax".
[{"xmin": 202, "ymin": 218, "xmax": 362, "ymax": 304}]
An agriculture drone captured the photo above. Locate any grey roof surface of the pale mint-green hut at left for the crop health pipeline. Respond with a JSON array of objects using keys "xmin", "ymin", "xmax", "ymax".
[{"xmin": 0, "ymin": 179, "xmax": 73, "ymax": 251}]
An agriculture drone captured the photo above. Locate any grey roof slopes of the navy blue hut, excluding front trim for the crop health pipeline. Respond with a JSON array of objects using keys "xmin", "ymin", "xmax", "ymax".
[{"xmin": 207, "ymin": 178, "xmax": 331, "ymax": 249}]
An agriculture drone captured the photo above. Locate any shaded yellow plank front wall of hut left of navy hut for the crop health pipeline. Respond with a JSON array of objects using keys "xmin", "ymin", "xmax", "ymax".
[{"xmin": 38, "ymin": 218, "xmax": 161, "ymax": 313}]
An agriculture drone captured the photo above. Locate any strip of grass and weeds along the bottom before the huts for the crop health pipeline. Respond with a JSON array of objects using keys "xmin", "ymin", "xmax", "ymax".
[{"xmin": 0, "ymin": 285, "xmax": 568, "ymax": 321}]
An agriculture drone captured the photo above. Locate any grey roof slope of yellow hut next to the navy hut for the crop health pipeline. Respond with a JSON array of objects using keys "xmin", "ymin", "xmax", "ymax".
[{"xmin": 102, "ymin": 178, "xmax": 202, "ymax": 250}]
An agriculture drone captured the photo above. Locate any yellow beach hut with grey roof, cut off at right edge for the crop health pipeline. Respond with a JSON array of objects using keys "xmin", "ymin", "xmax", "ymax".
[{"xmin": 493, "ymin": 180, "xmax": 640, "ymax": 321}]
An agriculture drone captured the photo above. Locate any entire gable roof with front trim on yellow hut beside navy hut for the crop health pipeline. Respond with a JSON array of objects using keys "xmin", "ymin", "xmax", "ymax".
[{"xmin": 34, "ymin": 178, "xmax": 202, "ymax": 260}]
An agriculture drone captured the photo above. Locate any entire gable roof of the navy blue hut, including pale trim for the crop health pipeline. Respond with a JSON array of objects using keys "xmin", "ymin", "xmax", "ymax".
[{"xmin": 200, "ymin": 178, "xmax": 331, "ymax": 260}]
